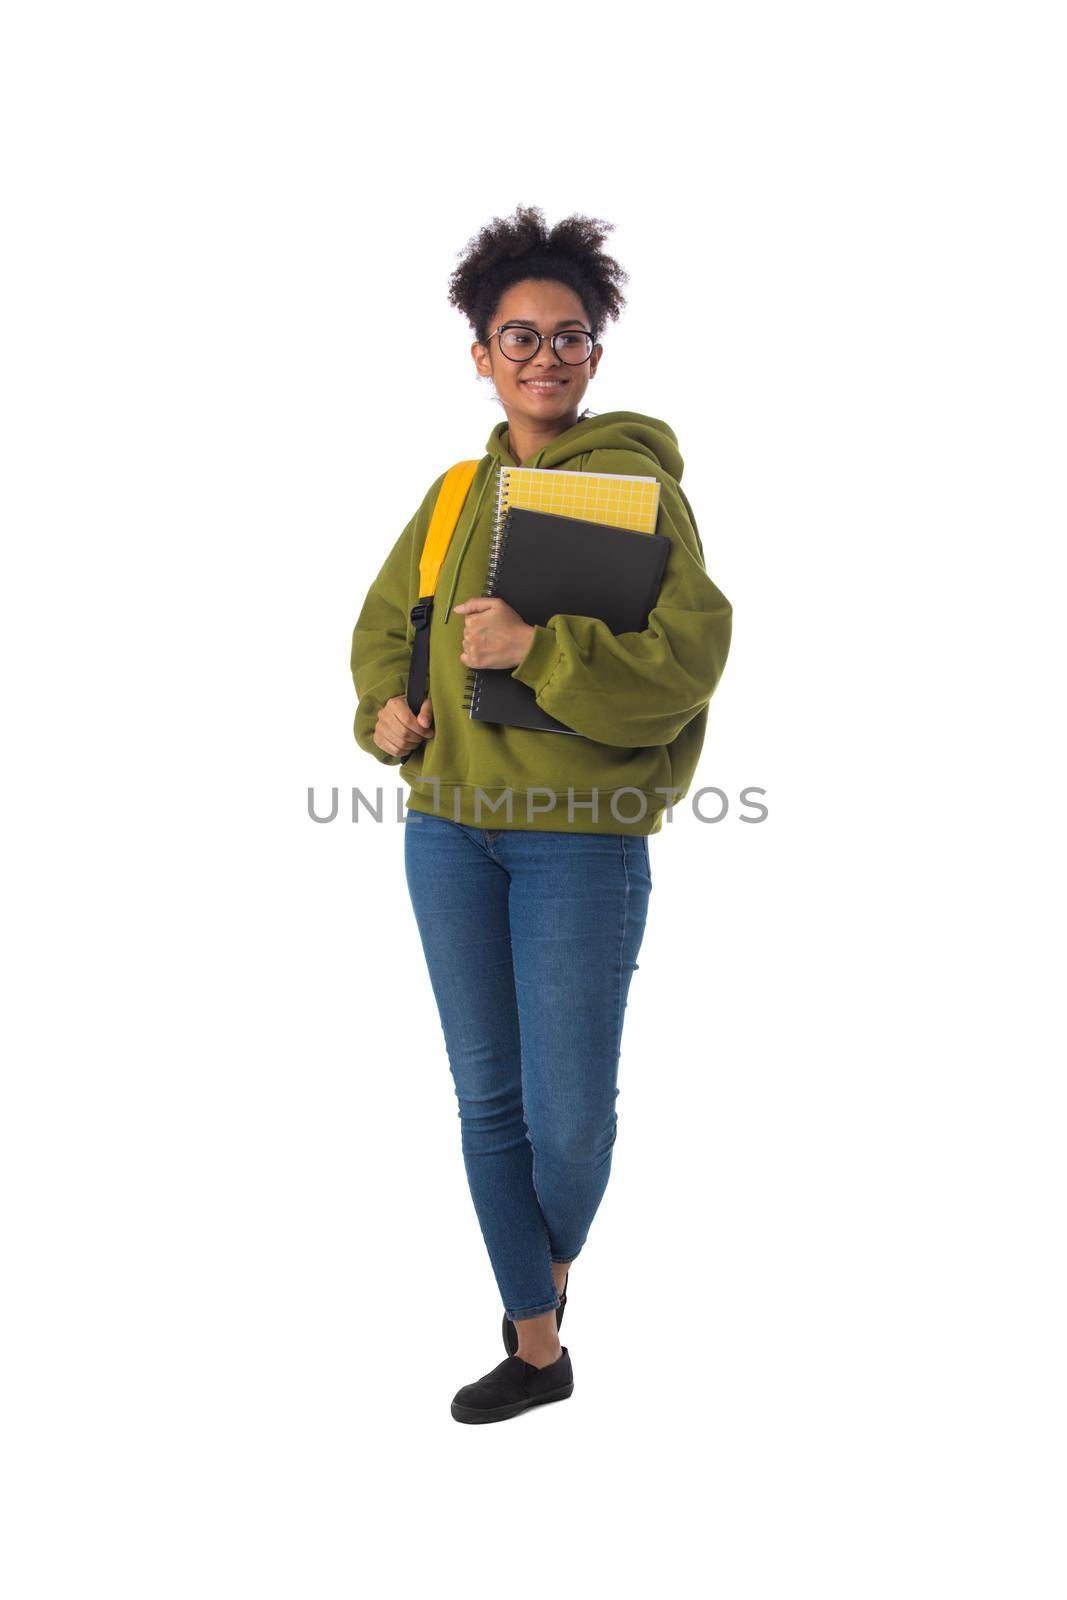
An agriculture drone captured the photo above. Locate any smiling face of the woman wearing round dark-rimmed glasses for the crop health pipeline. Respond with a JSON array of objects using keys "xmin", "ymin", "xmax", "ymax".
[{"xmin": 470, "ymin": 278, "xmax": 603, "ymax": 429}]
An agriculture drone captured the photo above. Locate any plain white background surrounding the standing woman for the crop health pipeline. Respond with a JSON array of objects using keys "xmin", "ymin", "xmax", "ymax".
[{"xmin": 0, "ymin": 0, "xmax": 1067, "ymax": 1600}]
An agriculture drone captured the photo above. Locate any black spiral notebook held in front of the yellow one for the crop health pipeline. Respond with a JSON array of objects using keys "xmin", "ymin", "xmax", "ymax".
[{"xmin": 464, "ymin": 506, "xmax": 670, "ymax": 733}]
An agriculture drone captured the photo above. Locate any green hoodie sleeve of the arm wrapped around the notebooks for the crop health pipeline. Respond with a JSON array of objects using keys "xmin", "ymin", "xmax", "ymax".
[{"xmin": 512, "ymin": 451, "xmax": 733, "ymax": 749}]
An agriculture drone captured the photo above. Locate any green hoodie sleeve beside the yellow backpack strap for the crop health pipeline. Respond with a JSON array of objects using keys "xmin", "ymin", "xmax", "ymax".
[{"xmin": 350, "ymin": 474, "xmax": 445, "ymax": 766}]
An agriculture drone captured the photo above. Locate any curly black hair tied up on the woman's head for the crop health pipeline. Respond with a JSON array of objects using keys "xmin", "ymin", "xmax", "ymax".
[{"xmin": 448, "ymin": 205, "xmax": 629, "ymax": 344}]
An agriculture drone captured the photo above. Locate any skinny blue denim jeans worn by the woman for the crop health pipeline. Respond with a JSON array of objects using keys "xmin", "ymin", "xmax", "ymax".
[{"xmin": 405, "ymin": 811, "xmax": 653, "ymax": 1322}]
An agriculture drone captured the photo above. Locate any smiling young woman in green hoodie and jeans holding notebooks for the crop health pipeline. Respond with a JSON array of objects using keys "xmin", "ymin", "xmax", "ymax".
[{"xmin": 352, "ymin": 206, "xmax": 733, "ymax": 1422}]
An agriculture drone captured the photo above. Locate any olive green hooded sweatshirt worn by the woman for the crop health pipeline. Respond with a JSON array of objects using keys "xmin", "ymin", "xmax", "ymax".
[{"xmin": 352, "ymin": 411, "xmax": 733, "ymax": 834}]
